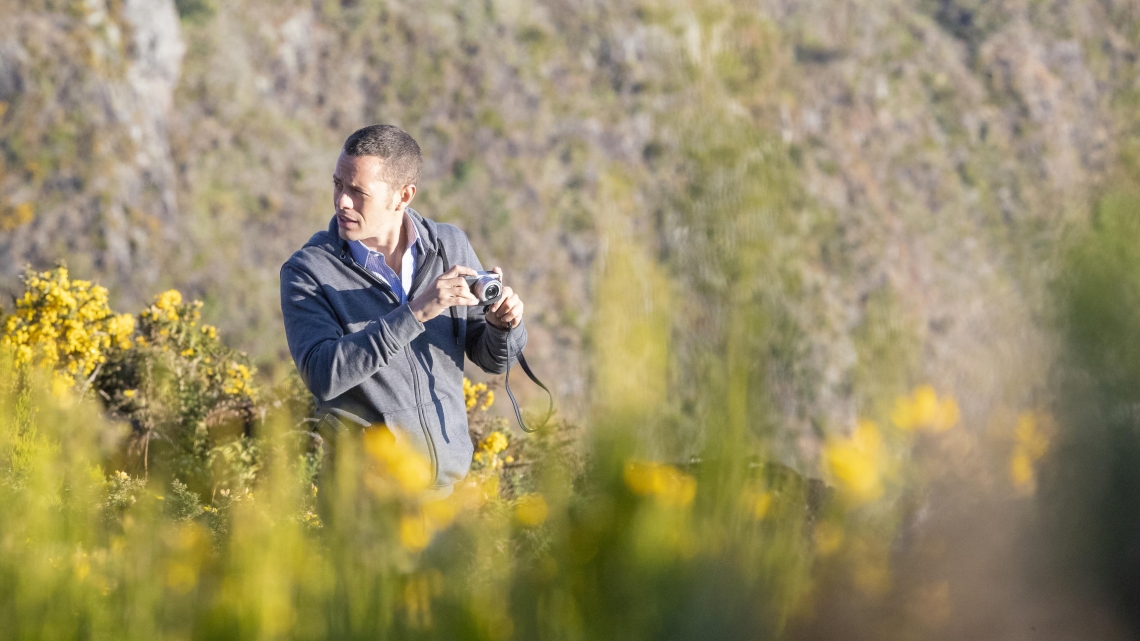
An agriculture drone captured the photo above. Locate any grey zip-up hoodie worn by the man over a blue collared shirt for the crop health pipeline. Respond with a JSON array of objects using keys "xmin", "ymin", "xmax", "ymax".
[{"xmin": 280, "ymin": 208, "xmax": 527, "ymax": 493}]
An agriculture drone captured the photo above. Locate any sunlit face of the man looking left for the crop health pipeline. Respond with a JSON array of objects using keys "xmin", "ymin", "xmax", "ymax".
[{"xmin": 333, "ymin": 153, "xmax": 415, "ymax": 241}]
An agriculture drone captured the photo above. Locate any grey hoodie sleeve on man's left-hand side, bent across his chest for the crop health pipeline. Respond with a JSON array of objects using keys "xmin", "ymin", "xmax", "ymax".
[{"xmin": 280, "ymin": 263, "xmax": 424, "ymax": 401}]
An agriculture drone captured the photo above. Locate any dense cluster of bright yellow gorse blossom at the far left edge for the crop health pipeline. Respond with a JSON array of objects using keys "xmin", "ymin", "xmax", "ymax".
[{"xmin": 0, "ymin": 266, "xmax": 135, "ymax": 386}]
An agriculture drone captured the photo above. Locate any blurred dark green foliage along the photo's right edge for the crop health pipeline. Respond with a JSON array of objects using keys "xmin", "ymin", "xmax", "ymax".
[{"xmin": 1042, "ymin": 190, "xmax": 1140, "ymax": 624}]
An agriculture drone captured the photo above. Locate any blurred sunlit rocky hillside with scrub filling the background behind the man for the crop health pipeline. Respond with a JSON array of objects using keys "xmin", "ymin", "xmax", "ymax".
[{"xmin": 0, "ymin": 0, "xmax": 1140, "ymax": 460}]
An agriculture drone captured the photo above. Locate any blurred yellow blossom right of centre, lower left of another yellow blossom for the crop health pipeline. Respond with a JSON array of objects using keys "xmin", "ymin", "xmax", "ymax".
[{"xmin": 824, "ymin": 420, "xmax": 888, "ymax": 504}]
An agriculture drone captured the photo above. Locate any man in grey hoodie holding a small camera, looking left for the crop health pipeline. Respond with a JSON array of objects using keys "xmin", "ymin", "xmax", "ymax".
[{"xmin": 280, "ymin": 124, "xmax": 527, "ymax": 496}]
